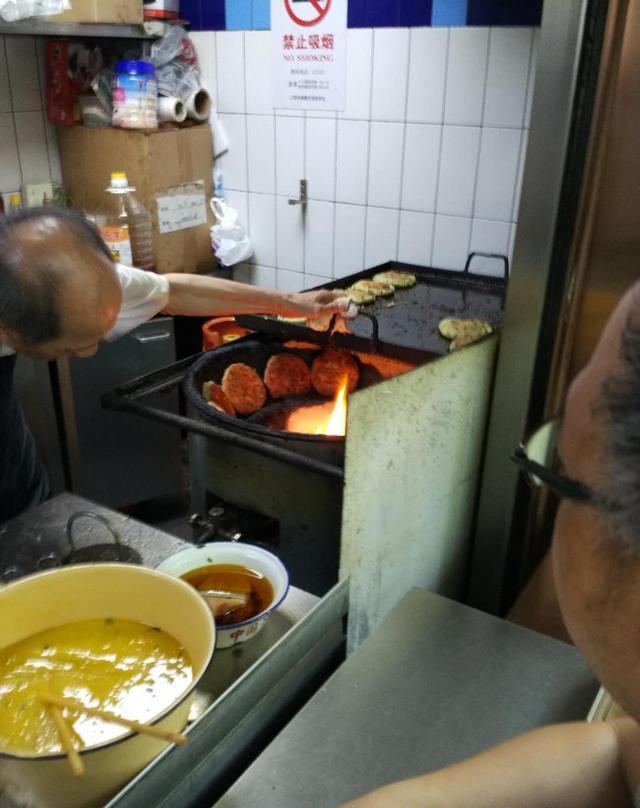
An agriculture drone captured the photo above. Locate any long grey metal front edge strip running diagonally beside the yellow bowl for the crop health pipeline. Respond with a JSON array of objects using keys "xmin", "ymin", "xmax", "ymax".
[{"xmin": 109, "ymin": 582, "xmax": 349, "ymax": 808}]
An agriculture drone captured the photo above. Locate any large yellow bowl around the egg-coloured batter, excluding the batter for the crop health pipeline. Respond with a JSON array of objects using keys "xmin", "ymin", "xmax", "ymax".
[{"xmin": 0, "ymin": 564, "xmax": 215, "ymax": 808}]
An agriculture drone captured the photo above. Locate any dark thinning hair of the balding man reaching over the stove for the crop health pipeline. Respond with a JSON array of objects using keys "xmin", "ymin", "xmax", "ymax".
[{"xmin": 0, "ymin": 208, "xmax": 111, "ymax": 345}]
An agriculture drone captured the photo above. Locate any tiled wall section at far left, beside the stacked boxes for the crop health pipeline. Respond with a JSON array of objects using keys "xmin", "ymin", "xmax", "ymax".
[{"xmin": 0, "ymin": 36, "xmax": 62, "ymax": 195}]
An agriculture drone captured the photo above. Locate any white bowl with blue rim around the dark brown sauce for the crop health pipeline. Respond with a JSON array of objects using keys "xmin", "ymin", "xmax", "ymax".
[{"xmin": 156, "ymin": 541, "xmax": 289, "ymax": 649}]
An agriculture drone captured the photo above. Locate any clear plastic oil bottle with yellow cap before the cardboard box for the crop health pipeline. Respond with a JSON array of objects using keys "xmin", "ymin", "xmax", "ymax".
[{"xmin": 96, "ymin": 171, "xmax": 155, "ymax": 270}]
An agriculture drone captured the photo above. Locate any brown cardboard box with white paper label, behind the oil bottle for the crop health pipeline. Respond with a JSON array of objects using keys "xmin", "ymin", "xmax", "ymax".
[{"xmin": 58, "ymin": 124, "xmax": 215, "ymax": 273}]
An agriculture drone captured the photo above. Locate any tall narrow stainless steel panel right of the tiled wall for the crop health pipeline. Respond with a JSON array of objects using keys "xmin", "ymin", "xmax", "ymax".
[{"xmin": 469, "ymin": 0, "xmax": 588, "ymax": 612}]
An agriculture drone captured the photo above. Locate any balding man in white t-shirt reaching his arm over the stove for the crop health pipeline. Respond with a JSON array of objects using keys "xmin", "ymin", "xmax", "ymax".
[{"xmin": 0, "ymin": 208, "xmax": 351, "ymax": 525}]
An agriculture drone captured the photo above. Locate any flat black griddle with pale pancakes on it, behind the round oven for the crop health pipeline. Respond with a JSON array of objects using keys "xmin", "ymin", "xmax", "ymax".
[{"xmin": 236, "ymin": 253, "xmax": 508, "ymax": 363}]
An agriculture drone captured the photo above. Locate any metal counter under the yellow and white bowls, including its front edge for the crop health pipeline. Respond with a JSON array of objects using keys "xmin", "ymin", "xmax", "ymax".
[{"xmin": 0, "ymin": 494, "xmax": 348, "ymax": 808}]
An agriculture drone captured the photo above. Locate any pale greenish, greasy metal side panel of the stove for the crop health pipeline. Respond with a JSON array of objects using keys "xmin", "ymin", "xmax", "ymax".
[{"xmin": 340, "ymin": 334, "xmax": 498, "ymax": 650}]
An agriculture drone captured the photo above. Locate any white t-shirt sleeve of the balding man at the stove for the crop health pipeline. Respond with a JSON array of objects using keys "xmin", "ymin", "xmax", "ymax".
[{"xmin": 0, "ymin": 264, "xmax": 169, "ymax": 356}]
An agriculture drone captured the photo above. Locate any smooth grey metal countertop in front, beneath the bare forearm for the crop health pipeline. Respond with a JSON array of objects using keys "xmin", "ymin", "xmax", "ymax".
[{"xmin": 215, "ymin": 589, "xmax": 598, "ymax": 808}]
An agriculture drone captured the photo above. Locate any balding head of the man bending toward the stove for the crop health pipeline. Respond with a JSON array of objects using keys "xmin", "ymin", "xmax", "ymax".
[{"xmin": 0, "ymin": 208, "xmax": 121, "ymax": 358}]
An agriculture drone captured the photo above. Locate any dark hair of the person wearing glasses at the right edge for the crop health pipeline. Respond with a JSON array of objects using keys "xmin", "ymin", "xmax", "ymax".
[{"xmin": 596, "ymin": 290, "xmax": 640, "ymax": 552}]
